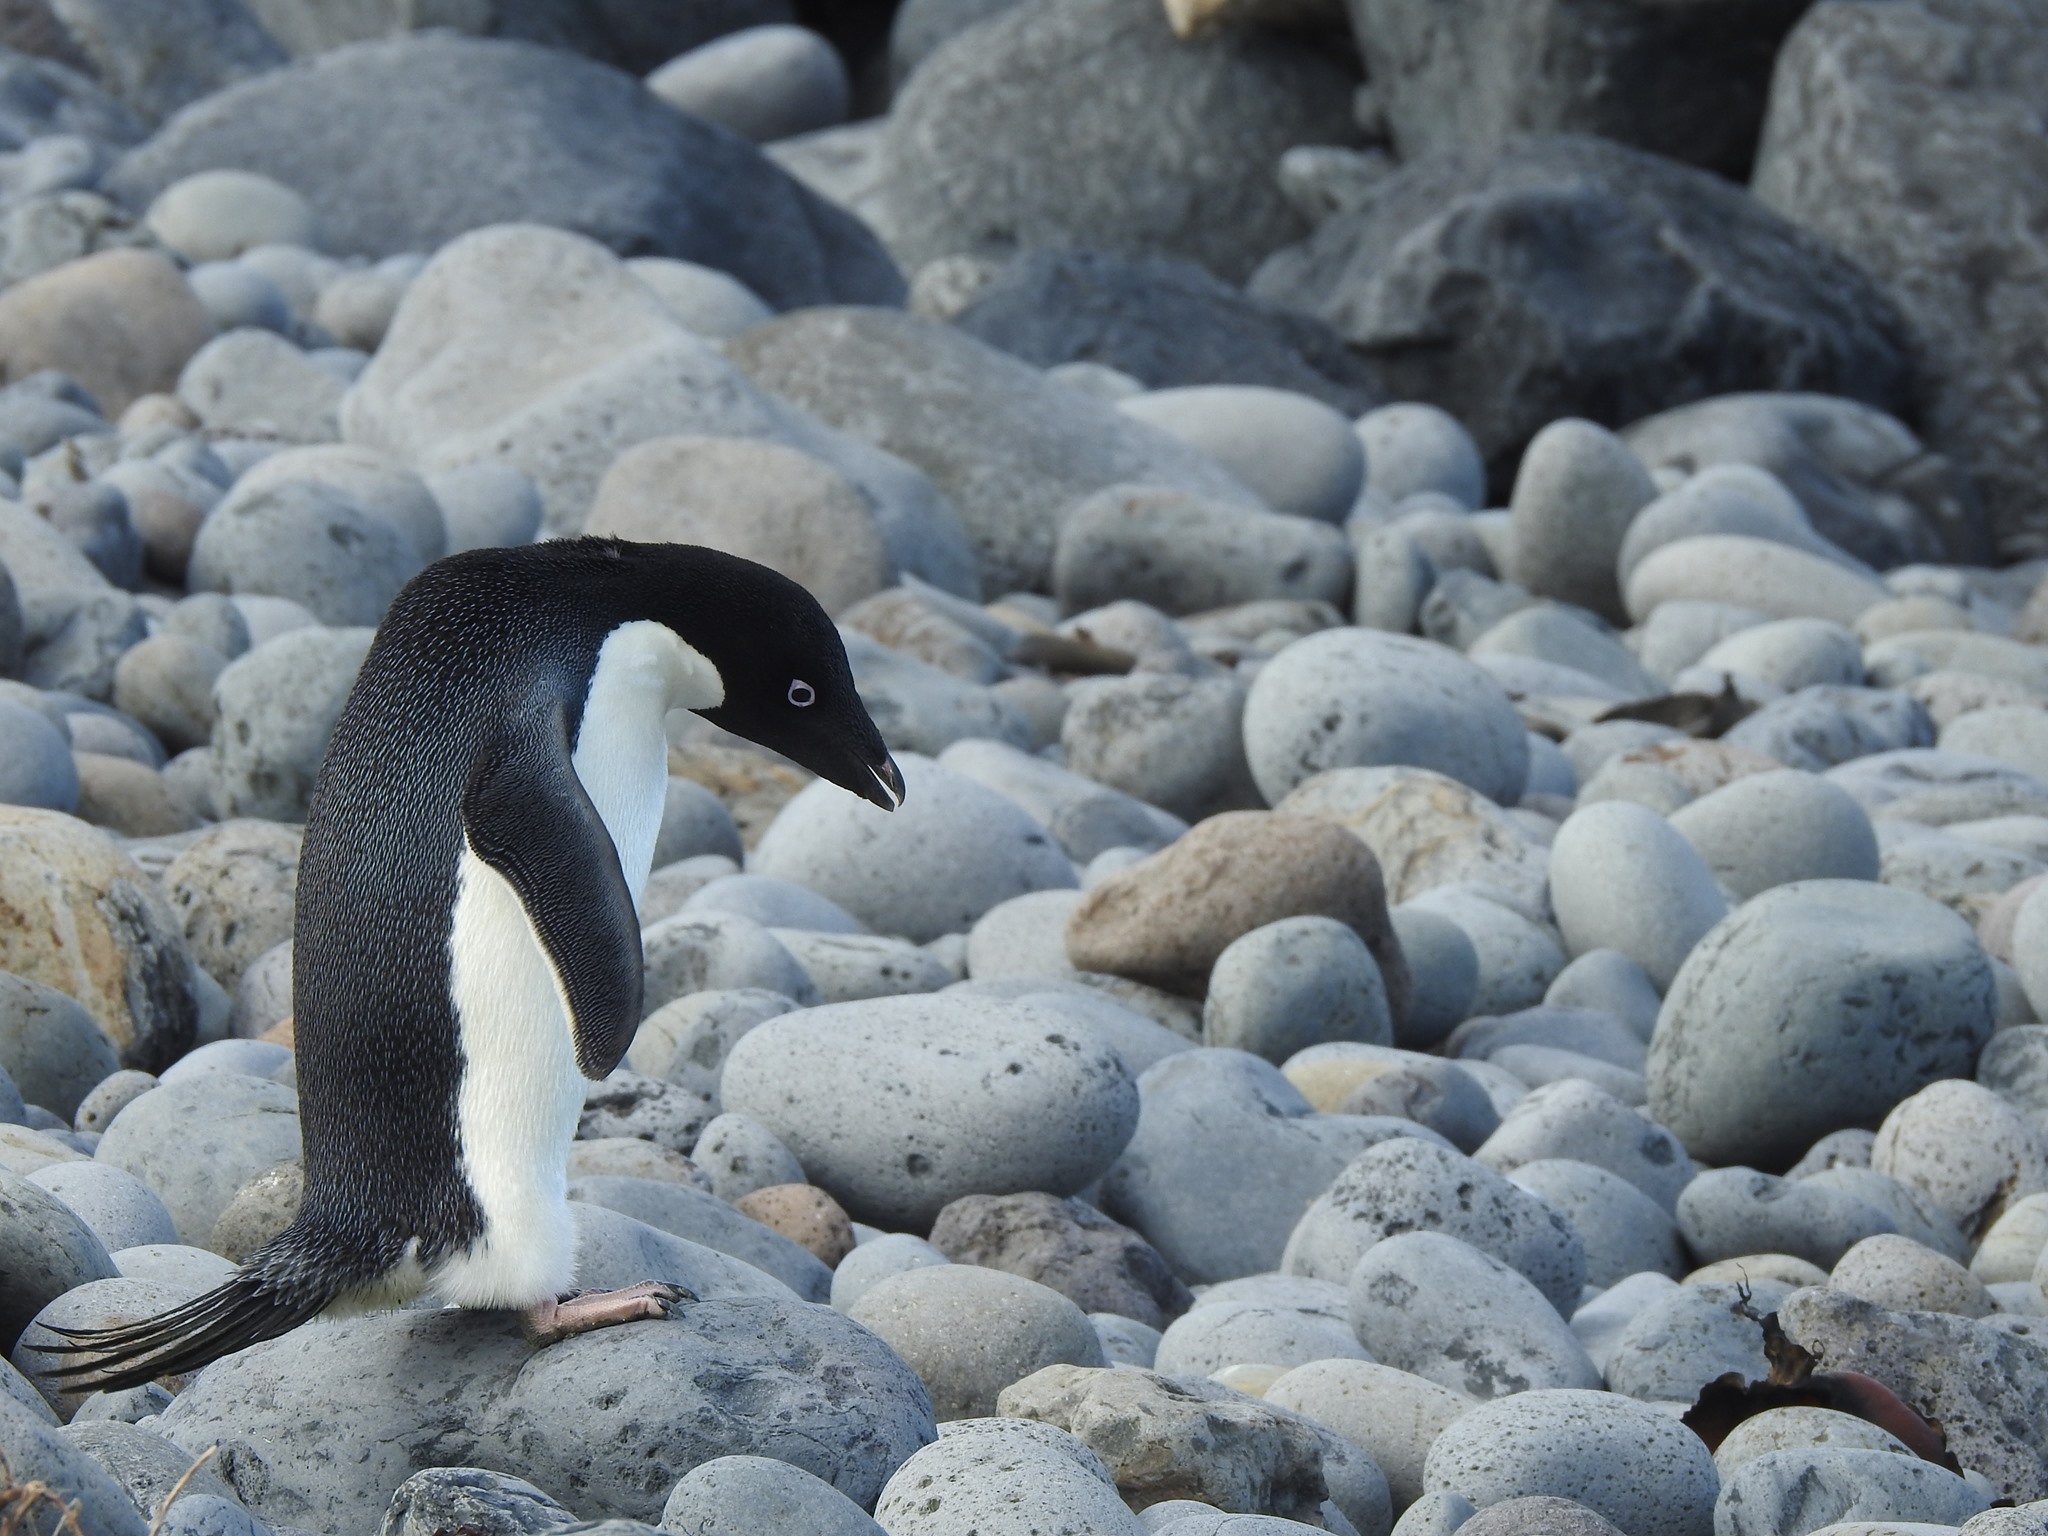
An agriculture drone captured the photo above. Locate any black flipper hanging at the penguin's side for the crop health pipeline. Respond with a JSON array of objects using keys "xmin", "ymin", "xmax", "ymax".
[{"xmin": 463, "ymin": 700, "xmax": 641, "ymax": 1079}]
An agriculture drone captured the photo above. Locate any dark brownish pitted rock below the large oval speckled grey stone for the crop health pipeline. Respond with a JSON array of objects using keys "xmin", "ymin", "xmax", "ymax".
[{"xmin": 932, "ymin": 1192, "xmax": 1194, "ymax": 1329}]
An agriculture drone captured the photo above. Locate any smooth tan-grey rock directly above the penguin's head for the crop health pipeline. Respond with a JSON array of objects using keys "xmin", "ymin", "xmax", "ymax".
[{"xmin": 584, "ymin": 436, "xmax": 895, "ymax": 612}]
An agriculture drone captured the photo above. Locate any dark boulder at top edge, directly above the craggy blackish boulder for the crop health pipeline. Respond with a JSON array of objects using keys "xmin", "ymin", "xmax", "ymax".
[{"xmin": 1348, "ymin": 0, "xmax": 1812, "ymax": 178}]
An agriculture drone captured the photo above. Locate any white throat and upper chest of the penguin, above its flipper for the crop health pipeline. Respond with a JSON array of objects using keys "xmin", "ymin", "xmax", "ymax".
[{"xmin": 569, "ymin": 618, "xmax": 725, "ymax": 907}]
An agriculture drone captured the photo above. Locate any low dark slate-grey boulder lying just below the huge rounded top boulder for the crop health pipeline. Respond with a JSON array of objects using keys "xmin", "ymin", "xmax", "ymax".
[{"xmin": 952, "ymin": 250, "xmax": 1380, "ymax": 416}]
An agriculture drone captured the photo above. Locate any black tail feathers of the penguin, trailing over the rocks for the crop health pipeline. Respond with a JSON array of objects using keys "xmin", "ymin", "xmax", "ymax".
[{"xmin": 34, "ymin": 1272, "xmax": 332, "ymax": 1393}]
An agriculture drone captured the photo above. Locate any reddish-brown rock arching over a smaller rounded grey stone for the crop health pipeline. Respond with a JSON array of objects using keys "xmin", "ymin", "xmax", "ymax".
[{"xmin": 1067, "ymin": 811, "xmax": 1409, "ymax": 1028}]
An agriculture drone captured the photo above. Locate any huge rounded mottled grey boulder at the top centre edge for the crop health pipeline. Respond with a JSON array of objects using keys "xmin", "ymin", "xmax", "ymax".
[{"xmin": 885, "ymin": 0, "xmax": 1358, "ymax": 283}]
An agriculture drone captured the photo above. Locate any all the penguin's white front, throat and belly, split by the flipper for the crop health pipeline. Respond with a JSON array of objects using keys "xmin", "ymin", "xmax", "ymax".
[{"xmin": 432, "ymin": 621, "xmax": 725, "ymax": 1307}]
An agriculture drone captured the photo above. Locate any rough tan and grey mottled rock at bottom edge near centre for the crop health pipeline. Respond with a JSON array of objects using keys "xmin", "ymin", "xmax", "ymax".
[{"xmin": 995, "ymin": 1366, "xmax": 1329, "ymax": 1524}]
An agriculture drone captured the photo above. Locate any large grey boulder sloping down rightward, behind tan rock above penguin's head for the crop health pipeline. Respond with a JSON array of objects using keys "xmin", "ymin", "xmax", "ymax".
[{"xmin": 727, "ymin": 309, "xmax": 1264, "ymax": 592}]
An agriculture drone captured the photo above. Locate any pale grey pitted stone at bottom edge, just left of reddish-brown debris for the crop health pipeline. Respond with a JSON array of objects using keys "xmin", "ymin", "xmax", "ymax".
[{"xmin": 1423, "ymin": 1391, "xmax": 1720, "ymax": 1536}]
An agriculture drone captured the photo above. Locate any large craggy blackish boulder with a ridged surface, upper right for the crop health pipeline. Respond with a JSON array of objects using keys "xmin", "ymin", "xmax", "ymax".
[{"xmin": 1249, "ymin": 135, "xmax": 1913, "ymax": 483}]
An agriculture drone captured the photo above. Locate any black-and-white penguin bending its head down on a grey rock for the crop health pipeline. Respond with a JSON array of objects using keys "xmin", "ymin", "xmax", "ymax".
[{"xmin": 39, "ymin": 539, "xmax": 903, "ymax": 1391}]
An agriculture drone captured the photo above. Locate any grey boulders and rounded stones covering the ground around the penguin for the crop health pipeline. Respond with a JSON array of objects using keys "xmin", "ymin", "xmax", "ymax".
[{"xmin": 0, "ymin": 0, "xmax": 2048, "ymax": 1536}]
